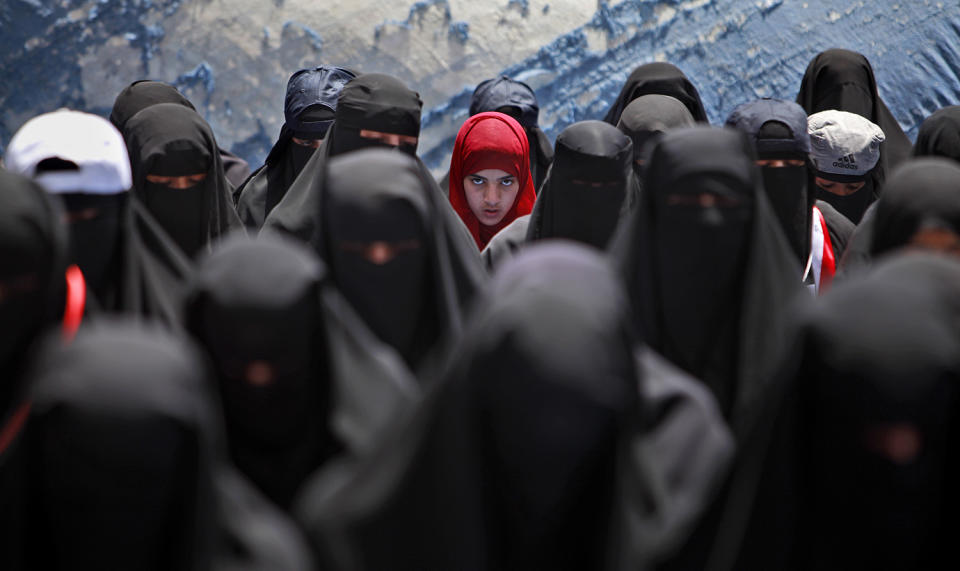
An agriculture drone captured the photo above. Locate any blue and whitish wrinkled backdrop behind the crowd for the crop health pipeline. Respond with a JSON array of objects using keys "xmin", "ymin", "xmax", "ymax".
[{"xmin": 0, "ymin": 0, "xmax": 960, "ymax": 174}]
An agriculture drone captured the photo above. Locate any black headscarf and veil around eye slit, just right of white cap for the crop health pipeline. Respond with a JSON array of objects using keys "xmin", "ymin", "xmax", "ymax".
[{"xmin": 125, "ymin": 103, "xmax": 241, "ymax": 258}]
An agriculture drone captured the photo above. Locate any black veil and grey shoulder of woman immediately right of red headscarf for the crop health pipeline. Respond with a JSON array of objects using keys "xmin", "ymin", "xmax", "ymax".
[{"xmin": 481, "ymin": 121, "xmax": 640, "ymax": 271}]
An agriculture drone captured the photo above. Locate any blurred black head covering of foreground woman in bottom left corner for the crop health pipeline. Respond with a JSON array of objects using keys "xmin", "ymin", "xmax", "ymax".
[{"xmin": 12, "ymin": 320, "xmax": 309, "ymax": 569}]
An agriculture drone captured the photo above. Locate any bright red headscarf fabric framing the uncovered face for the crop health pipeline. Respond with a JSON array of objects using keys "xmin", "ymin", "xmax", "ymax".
[{"xmin": 449, "ymin": 111, "xmax": 537, "ymax": 250}]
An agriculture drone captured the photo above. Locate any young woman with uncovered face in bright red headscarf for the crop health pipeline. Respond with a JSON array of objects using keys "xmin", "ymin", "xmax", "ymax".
[{"xmin": 450, "ymin": 112, "xmax": 536, "ymax": 250}]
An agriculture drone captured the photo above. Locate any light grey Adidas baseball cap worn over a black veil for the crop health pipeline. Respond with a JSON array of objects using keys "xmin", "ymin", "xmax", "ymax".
[{"xmin": 807, "ymin": 109, "xmax": 886, "ymax": 182}]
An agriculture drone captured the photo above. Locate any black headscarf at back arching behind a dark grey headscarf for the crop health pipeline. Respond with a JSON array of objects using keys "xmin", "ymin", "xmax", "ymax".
[{"xmin": 603, "ymin": 62, "xmax": 708, "ymax": 125}]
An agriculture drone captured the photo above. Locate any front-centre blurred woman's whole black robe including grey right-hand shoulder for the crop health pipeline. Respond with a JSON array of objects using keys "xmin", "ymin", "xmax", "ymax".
[{"xmin": 290, "ymin": 244, "xmax": 731, "ymax": 570}]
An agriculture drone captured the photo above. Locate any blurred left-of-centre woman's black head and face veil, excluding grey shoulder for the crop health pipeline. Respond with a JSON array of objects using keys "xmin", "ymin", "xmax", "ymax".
[{"xmin": 186, "ymin": 235, "xmax": 340, "ymax": 507}]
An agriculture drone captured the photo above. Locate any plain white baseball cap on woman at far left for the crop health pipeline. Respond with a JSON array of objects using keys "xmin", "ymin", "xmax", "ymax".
[{"xmin": 4, "ymin": 109, "xmax": 133, "ymax": 194}]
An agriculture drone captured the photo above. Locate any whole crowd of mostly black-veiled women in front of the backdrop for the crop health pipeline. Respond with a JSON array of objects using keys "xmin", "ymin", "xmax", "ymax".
[{"xmin": 0, "ymin": 49, "xmax": 960, "ymax": 571}]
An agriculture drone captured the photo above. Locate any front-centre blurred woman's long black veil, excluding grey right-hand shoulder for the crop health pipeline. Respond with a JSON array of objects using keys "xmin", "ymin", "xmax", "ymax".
[{"xmin": 299, "ymin": 245, "xmax": 637, "ymax": 569}]
